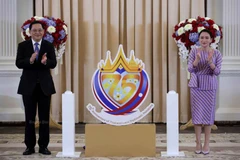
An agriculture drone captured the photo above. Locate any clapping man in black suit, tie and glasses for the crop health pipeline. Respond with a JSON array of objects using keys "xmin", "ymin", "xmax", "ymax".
[{"xmin": 16, "ymin": 21, "xmax": 57, "ymax": 155}]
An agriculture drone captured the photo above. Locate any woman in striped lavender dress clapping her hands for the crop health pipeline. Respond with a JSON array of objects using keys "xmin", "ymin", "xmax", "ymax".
[{"xmin": 188, "ymin": 29, "xmax": 222, "ymax": 154}]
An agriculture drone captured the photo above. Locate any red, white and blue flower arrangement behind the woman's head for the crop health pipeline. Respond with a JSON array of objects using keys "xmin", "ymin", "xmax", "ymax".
[{"xmin": 172, "ymin": 16, "xmax": 222, "ymax": 61}]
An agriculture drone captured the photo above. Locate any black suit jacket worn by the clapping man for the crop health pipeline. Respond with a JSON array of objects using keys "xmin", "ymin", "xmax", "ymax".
[{"xmin": 16, "ymin": 39, "xmax": 57, "ymax": 95}]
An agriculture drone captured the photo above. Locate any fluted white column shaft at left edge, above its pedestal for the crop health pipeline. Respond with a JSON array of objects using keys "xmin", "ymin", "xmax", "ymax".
[{"xmin": 0, "ymin": 0, "xmax": 17, "ymax": 72}]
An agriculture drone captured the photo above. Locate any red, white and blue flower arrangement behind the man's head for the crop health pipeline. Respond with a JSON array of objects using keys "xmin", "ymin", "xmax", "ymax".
[{"xmin": 21, "ymin": 16, "xmax": 68, "ymax": 59}]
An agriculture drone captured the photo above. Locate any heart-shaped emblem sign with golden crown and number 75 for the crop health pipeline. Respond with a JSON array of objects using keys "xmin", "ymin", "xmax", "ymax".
[{"xmin": 87, "ymin": 45, "xmax": 154, "ymax": 126}]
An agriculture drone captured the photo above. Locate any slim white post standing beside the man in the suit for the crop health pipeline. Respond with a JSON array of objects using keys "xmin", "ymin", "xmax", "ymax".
[{"xmin": 56, "ymin": 91, "xmax": 81, "ymax": 157}]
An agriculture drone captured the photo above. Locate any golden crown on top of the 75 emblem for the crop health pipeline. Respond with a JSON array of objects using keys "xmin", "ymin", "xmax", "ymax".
[{"xmin": 98, "ymin": 45, "xmax": 144, "ymax": 72}]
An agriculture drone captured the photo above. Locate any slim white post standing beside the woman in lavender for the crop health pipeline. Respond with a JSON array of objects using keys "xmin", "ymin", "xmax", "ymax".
[{"xmin": 161, "ymin": 91, "xmax": 185, "ymax": 156}]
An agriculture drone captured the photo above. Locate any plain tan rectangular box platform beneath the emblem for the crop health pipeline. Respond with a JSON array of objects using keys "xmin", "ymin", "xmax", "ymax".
[{"xmin": 85, "ymin": 124, "xmax": 156, "ymax": 157}]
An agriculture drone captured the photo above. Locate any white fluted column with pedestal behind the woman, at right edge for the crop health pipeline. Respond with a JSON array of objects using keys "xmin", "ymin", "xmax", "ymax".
[{"xmin": 207, "ymin": 0, "xmax": 240, "ymax": 121}]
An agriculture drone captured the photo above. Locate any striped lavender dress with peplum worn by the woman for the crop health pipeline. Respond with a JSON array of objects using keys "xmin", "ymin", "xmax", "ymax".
[{"xmin": 188, "ymin": 48, "xmax": 222, "ymax": 125}]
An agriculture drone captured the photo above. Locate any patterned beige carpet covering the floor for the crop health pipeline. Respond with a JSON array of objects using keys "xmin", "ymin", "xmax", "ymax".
[{"xmin": 0, "ymin": 133, "xmax": 240, "ymax": 160}]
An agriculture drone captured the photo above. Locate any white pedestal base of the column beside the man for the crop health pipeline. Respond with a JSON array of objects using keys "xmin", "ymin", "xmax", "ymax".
[{"xmin": 0, "ymin": 69, "xmax": 25, "ymax": 122}]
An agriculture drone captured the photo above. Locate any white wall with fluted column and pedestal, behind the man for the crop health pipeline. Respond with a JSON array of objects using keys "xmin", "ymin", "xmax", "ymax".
[{"xmin": 0, "ymin": 0, "xmax": 33, "ymax": 121}]
